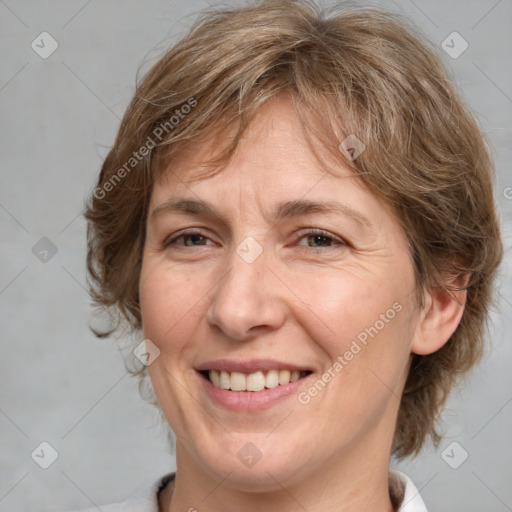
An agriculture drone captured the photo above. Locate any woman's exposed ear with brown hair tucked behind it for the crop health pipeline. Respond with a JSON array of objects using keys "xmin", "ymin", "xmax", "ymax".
[{"xmin": 411, "ymin": 274, "xmax": 469, "ymax": 355}]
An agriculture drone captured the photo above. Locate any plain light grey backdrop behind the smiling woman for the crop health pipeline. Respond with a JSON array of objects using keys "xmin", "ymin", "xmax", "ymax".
[{"xmin": 0, "ymin": 0, "xmax": 512, "ymax": 512}]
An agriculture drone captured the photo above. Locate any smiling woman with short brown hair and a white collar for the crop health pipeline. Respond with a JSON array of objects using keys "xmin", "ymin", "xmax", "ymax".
[{"xmin": 79, "ymin": 0, "xmax": 502, "ymax": 512}]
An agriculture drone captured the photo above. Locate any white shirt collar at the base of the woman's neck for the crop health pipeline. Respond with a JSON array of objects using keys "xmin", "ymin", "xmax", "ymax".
[{"xmin": 67, "ymin": 470, "xmax": 427, "ymax": 512}]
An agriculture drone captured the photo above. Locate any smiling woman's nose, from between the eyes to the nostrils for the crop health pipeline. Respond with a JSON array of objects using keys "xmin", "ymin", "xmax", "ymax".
[{"xmin": 206, "ymin": 242, "xmax": 287, "ymax": 341}]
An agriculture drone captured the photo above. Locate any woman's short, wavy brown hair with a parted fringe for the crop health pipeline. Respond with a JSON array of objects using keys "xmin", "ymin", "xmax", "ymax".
[{"xmin": 85, "ymin": 0, "xmax": 502, "ymax": 457}]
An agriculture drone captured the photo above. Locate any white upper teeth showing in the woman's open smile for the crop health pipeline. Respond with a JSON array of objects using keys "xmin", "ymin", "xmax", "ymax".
[{"xmin": 209, "ymin": 370, "xmax": 300, "ymax": 391}]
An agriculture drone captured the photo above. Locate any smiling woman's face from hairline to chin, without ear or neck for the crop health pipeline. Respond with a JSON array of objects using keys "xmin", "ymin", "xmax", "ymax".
[{"xmin": 140, "ymin": 94, "xmax": 419, "ymax": 490}]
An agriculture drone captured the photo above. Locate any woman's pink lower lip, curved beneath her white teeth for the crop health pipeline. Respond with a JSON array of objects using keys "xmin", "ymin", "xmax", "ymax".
[{"xmin": 198, "ymin": 373, "xmax": 312, "ymax": 411}]
